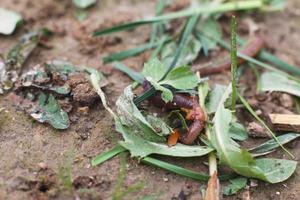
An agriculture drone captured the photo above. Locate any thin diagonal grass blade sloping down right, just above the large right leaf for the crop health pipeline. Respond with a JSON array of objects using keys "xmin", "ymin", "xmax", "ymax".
[{"xmin": 237, "ymin": 93, "xmax": 294, "ymax": 158}]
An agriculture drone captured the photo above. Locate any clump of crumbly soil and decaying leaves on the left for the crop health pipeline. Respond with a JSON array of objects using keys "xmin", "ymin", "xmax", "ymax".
[{"xmin": 15, "ymin": 60, "xmax": 106, "ymax": 129}]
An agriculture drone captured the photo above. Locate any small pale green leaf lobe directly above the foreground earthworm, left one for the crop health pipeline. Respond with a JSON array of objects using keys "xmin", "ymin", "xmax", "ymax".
[{"xmin": 142, "ymin": 58, "xmax": 167, "ymax": 82}]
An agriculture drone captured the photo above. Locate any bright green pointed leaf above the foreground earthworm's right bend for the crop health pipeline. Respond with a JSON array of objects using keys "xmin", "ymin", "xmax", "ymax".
[{"xmin": 159, "ymin": 66, "xmax": 198, "ymax": 90}]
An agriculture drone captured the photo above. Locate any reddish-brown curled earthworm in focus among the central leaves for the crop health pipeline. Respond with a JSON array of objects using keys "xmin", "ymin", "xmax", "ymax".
[{"xmin": 143, "ymin": 81, "xmax": 206, "ymax": 144}]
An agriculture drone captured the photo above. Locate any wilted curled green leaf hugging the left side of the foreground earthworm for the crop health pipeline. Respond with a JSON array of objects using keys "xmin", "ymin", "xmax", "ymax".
[{"xmin": 115, "ymin": 86, "xmax": 213, "ymax": 157}]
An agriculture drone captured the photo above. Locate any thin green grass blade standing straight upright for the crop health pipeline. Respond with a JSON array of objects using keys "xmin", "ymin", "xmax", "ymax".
[{"xmin": 230, "ymin": 16, "xmax": 238, "ymax": 112}]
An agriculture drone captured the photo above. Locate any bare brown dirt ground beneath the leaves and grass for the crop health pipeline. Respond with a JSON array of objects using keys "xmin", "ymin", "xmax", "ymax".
[{"xmin": 0, "ymin": 0, "xmax": 300, "ymax": 200}]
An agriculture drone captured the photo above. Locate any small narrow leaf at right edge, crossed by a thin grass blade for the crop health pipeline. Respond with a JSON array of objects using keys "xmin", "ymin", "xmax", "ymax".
[{"xmin": 250, "ymin": 133, "xmax": 300, "ymax": 155}]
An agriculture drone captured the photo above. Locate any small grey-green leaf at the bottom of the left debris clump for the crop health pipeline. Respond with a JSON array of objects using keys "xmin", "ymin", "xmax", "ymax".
[{"xmin": 30, "ymin": 93, "xmax": 70, "ymax": 129}]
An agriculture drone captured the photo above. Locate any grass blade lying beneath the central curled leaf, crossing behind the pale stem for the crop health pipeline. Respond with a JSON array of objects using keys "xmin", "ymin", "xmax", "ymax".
[{"xmin": 142, "ymin": 157, "xmax": 236, "ymax": 182}]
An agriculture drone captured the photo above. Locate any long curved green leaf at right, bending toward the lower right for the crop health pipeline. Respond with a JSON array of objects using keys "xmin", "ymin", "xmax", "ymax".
[{"xmin": 212, "ymin": 85, "xmax": 297, "ymax": 183}]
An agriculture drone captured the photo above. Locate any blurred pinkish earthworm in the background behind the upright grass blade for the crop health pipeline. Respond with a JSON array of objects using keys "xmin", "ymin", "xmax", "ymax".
[{"xmin": 192, "ymin": 36, "xmax": 264, "ymax": 76}]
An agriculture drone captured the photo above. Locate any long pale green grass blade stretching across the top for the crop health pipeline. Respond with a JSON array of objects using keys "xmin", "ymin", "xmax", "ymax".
[{"xmin": 93, "ymin": 0, "xmax": 263, "ymax": 36}]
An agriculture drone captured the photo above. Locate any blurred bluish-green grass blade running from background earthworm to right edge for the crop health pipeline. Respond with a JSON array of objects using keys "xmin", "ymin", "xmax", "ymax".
[{"xmin": 238, "ymin": 38, "xmax": 300, "ymax": 76}]
